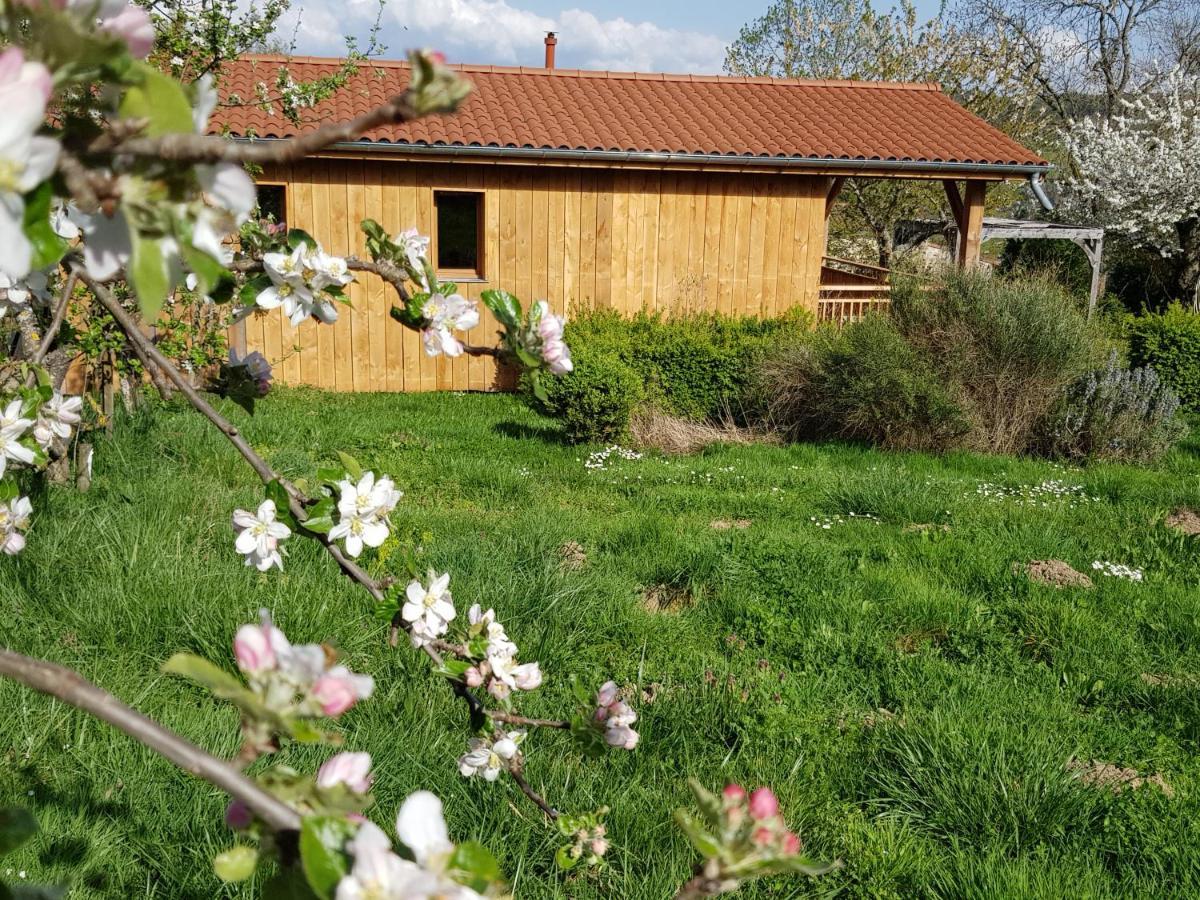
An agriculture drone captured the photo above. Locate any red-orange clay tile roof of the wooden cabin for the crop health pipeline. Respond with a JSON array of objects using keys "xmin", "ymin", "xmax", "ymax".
[{"xmin": 212, "ymin": 55, "xmax": 1046, "ymax": 167}]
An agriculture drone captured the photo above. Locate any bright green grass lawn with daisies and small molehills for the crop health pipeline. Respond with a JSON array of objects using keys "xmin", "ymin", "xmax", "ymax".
[{"xmin": 0, "ymin": 391, "xmax": 1200, "ymax": 899}]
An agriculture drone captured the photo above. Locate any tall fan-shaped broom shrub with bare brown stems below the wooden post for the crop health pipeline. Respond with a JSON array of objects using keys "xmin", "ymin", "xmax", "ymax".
[{"xmin": 892, "ymin": 271, "xmax": 1108, "ymax": 454}]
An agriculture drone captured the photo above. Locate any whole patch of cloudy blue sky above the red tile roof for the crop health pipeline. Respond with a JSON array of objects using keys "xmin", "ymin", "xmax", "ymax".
[{"xmin": 283, "ymin": 0, "xmax": 937, "ymax": 73}]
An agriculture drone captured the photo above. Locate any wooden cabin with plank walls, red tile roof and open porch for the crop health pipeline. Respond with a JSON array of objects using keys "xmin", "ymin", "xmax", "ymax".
[{"xmin": 212, "ymin": 55, "xmax": 1049, "ymax": 391}]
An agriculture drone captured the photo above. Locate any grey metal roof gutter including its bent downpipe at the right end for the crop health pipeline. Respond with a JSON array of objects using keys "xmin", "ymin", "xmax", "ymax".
[{"xmin": 234, "ymin": 138, "xmax": 1052, "ymax": 180}]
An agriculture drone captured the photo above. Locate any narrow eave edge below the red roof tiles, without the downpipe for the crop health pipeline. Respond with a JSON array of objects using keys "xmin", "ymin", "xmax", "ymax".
[{"xmin": 234, "ymin": 138, "xmax": 1052, "ymax": 181}]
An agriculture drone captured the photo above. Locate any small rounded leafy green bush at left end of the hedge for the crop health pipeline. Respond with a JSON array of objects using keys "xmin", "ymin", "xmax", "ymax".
[{"xmin": 542, "ymin": 347, "xmax": 646, "ymax": 444}]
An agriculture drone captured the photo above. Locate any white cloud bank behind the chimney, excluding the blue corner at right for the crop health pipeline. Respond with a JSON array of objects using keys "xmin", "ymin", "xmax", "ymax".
[{"xmin": 281, "ymin": 0, "xmax": 726, "ymax": 73}]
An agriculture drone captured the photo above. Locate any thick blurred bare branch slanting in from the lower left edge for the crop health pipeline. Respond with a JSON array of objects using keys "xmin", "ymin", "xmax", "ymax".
[{"xmin": 0, "ymin": 647, "xmax": 300, "ymax": 832}]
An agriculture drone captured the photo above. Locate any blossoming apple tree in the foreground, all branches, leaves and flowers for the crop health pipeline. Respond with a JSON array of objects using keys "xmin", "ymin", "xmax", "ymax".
[{"xmin": 0, "ymin": 0, "xmax": 828, "ymax": 900}]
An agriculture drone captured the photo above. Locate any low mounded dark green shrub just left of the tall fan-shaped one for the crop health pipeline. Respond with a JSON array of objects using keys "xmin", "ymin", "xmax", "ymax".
[{"xmin": 762, "ymin": 316, "xmax": 968, "ymax": 458}]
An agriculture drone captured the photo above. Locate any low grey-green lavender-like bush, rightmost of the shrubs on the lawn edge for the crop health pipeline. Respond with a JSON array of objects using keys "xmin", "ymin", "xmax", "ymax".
[{"xmin": 1044, "ymin": 350, "xmax": 1187, "ymax": 462}]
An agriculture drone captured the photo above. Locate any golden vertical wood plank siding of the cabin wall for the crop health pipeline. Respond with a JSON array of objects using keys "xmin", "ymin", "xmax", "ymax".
[{"xmin": 239, "ymin": 157, "xmax": 829, "ymax": 391}]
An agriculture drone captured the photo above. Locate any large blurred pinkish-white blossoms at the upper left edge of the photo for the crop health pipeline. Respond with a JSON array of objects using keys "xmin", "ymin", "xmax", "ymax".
[{"xmin": 0, "ymin": 47, "xmax": 61, "ymax": 278}]
